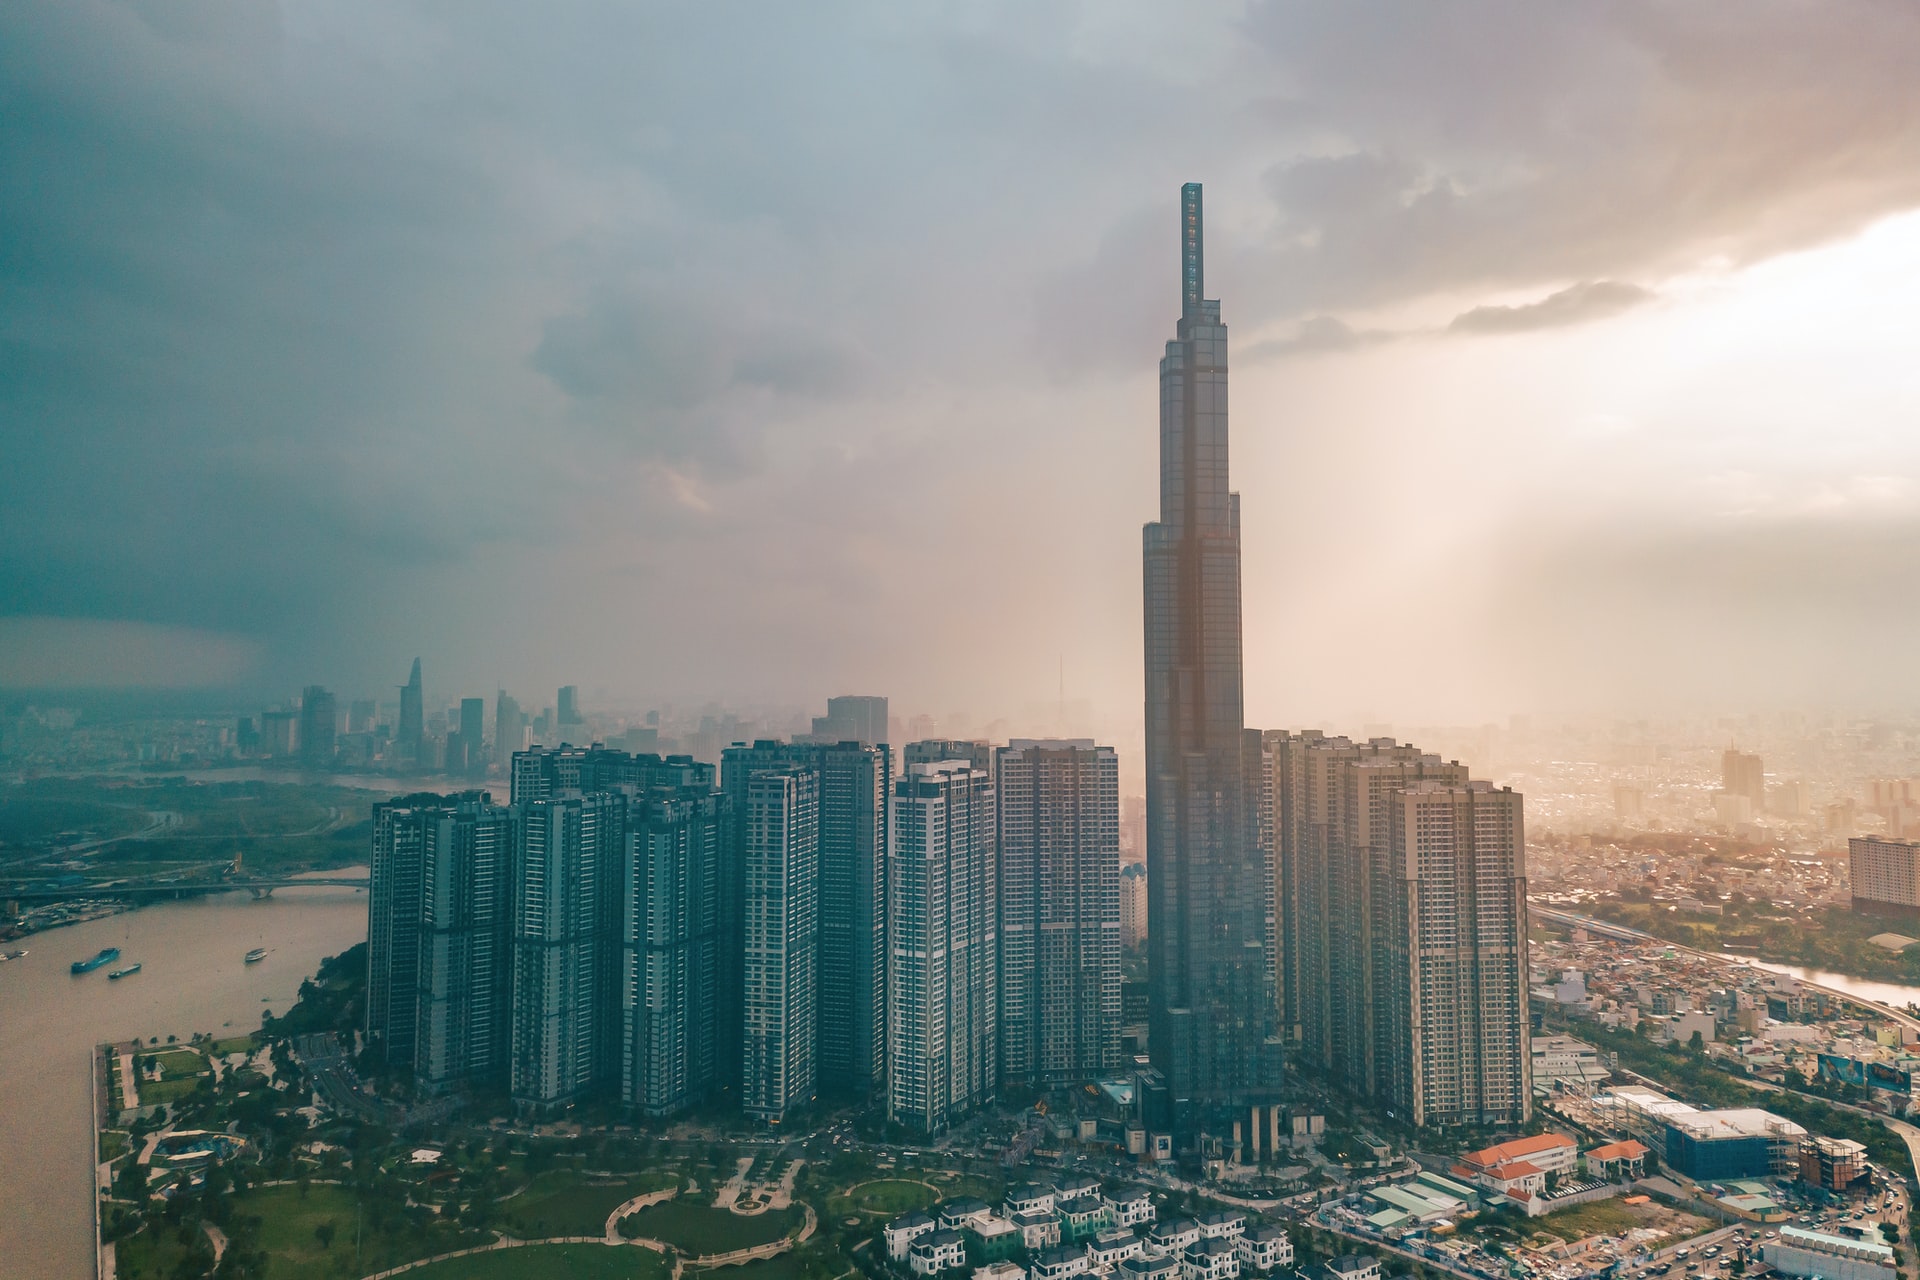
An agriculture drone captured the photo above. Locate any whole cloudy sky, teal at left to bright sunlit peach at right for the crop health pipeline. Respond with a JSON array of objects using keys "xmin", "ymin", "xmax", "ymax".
[{"xmin": 0, "ymin": 0, "xmax": 1920, "ymax": 736}]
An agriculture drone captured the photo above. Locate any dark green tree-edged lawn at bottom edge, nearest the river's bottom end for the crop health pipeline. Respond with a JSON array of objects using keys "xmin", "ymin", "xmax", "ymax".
[{"xmin": 234, "ymin": 1186, "xmax": 488, "ymax": 1280}]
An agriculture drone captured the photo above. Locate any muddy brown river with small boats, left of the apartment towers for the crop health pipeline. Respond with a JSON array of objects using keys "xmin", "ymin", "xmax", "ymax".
[{"xmin": 0, "ymin": 889, "xmax": 367, "ymax": 1280}]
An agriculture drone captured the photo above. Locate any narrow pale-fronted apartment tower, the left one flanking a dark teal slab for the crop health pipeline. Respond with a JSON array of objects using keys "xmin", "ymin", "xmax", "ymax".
[{"xmin": 739, "ymin": 764, "xmax": 820, "ymax": 1125}]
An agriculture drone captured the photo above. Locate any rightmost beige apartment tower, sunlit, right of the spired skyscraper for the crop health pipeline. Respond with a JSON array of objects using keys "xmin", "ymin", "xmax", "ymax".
[{"xmin": 1375, "ymin": 781, "xmax": 1532, "ymax": 1126}]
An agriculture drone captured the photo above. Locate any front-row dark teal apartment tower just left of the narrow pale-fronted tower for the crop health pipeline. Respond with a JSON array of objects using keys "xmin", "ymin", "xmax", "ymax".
[{"xmin": 620, "ymin": 785, "xmax": 726, "ymax": 1115}]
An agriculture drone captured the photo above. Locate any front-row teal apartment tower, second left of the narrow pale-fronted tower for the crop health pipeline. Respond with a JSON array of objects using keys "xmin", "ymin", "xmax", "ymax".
[{"xmin": 511, "ymin": 791, "xmax": 626, "ymax": 1109}]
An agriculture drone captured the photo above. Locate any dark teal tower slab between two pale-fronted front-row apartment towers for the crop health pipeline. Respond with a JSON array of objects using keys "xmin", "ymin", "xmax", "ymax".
[{"xmin": 816, "ymin": 740, "xmax": 893, "ymax": 1098}]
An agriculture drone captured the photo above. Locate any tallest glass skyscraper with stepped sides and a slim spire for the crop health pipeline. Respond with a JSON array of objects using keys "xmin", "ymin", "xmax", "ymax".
[{"xmin": 1144, "ymin": 182, "xmax": 1279, "ymax": 1134}]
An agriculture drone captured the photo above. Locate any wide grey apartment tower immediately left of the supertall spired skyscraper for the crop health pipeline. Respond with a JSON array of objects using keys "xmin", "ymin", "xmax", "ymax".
[{"xmin": 993, "ymin": 739, "xmax": 1119, "ymax": 1084}]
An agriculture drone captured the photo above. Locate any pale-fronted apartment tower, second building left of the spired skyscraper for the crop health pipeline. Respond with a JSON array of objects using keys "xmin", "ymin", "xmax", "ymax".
[{"xmin": 887, "ymin": 747, "xmax": 998, "ymax": 1134}]
